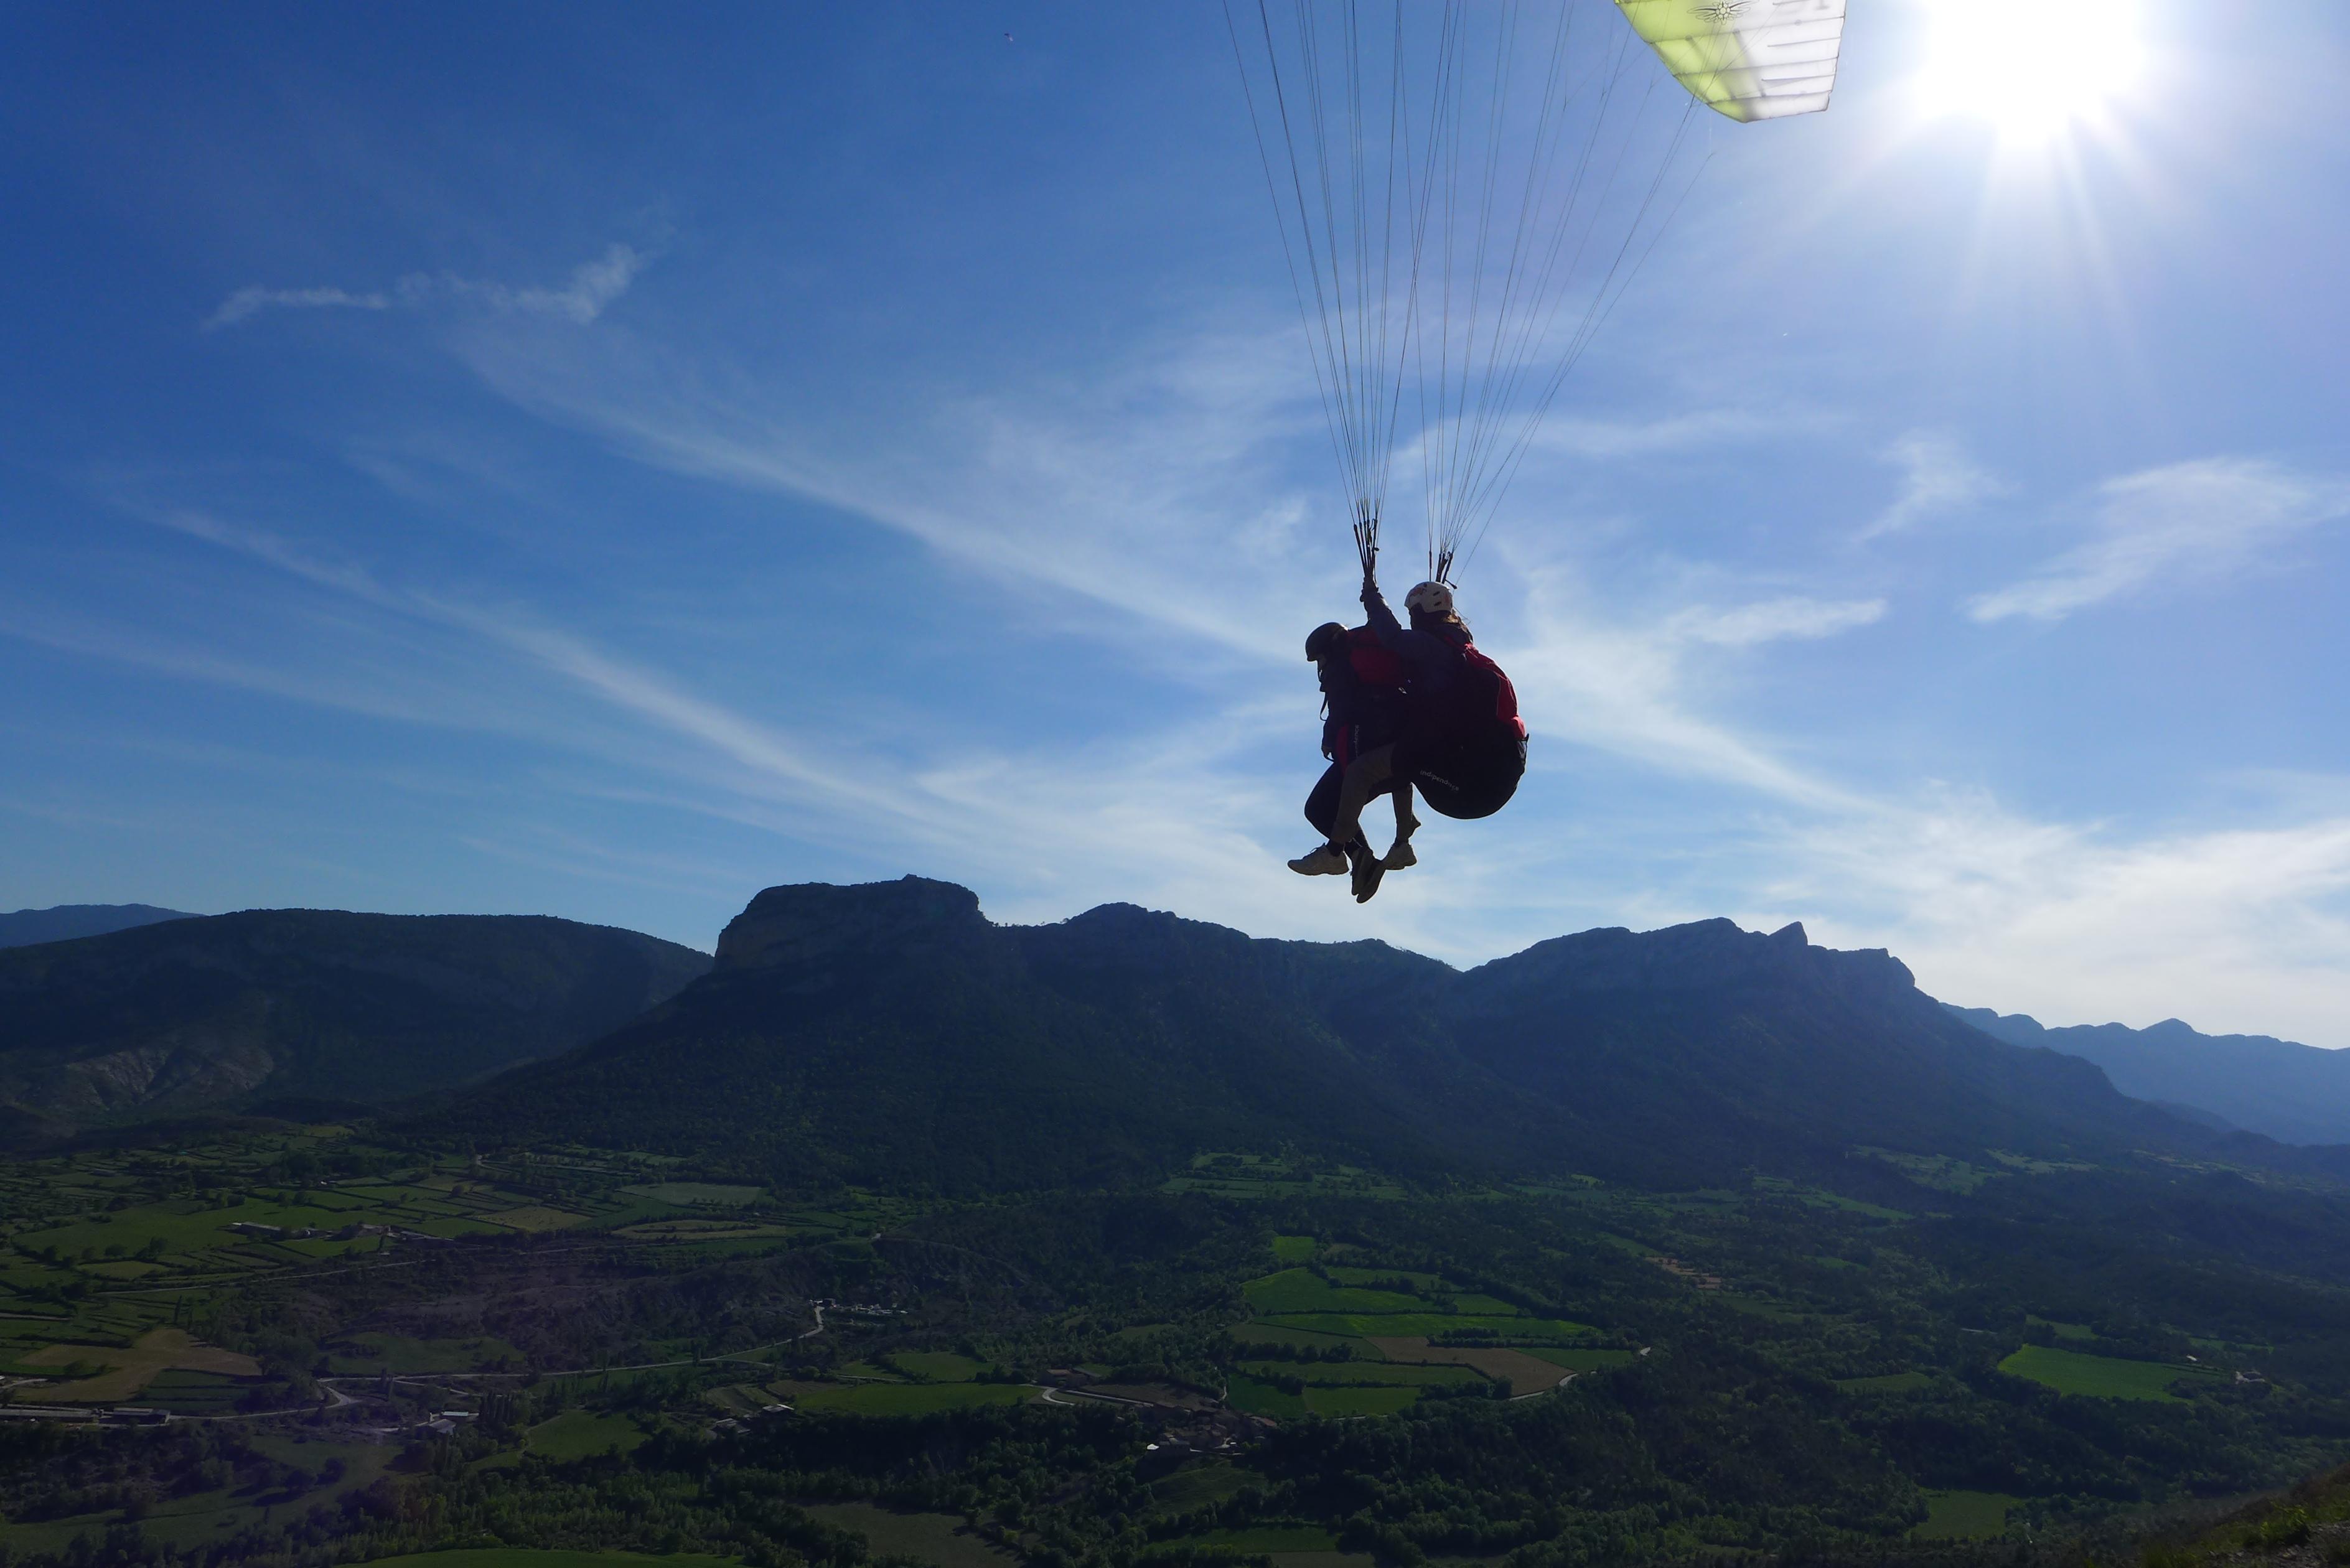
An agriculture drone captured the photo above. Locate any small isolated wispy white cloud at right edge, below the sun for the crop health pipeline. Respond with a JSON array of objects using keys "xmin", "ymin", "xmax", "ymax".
[{"xmin": 1967, "ymin": 459, "xmax": 2350, "ymax": 620}]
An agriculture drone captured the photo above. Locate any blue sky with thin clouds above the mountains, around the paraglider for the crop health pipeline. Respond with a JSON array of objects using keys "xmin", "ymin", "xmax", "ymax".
[{"xmin": 0, "ymin": 0, "xmax": 2350, "ymax": 1046}]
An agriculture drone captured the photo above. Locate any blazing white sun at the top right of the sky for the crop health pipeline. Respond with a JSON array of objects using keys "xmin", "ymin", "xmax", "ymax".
[{"xmin": 1917, "ymin": 0, "xmax": 2141, "ymax": 143}]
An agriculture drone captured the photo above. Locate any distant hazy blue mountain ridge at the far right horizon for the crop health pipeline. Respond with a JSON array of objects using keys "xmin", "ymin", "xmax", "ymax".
[{"xmin": 1950, "ymin": 1006, "xmax": 2350, "ymax": 1145}]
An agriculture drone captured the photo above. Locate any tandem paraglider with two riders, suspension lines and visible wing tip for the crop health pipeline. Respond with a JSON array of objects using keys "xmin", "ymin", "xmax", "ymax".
[{"xmin": 1224, "ymin": 0, "xmax": 1845, "ymax": 900}]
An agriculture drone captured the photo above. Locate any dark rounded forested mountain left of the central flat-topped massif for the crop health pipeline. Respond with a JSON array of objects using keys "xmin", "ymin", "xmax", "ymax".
[{"xmin": 0, "ymin": 910, "xmax": 709, "ymax": 1142}]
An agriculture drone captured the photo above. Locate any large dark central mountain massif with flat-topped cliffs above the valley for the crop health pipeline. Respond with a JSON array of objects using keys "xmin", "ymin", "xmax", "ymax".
[{"xmin": 433, "ymin": 877, "xmax": 2211, "ymax": 1190}]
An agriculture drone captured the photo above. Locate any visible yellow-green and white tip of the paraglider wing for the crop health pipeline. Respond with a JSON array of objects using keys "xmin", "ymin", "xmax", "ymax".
[{"xmin": 1617, "ymin": 0, "xmax": 1845, "ymax": 120}]
